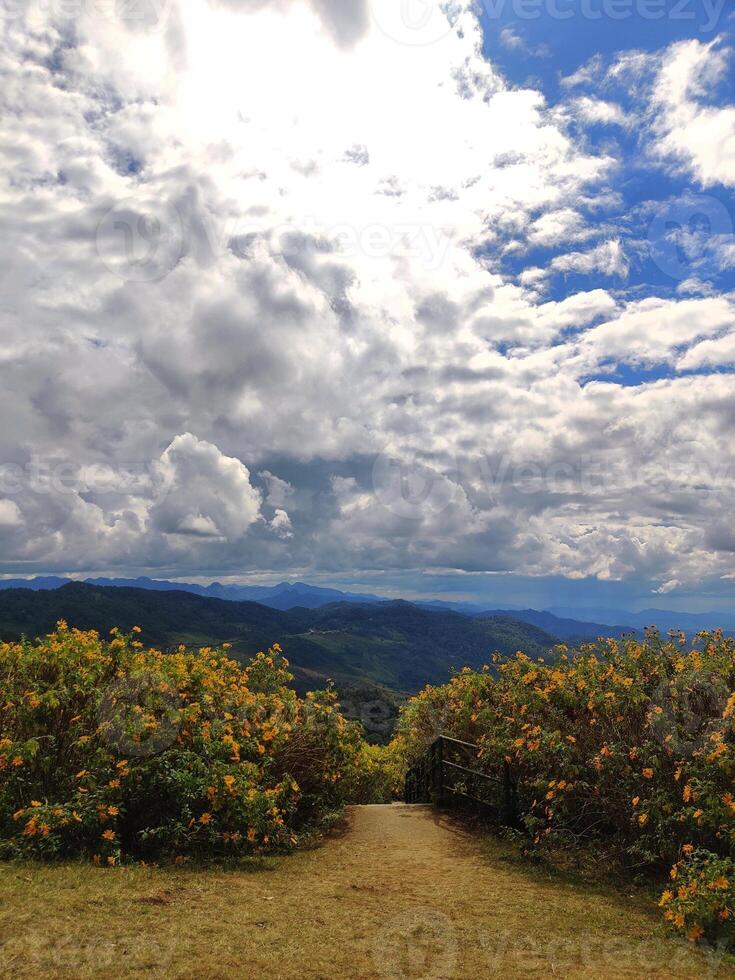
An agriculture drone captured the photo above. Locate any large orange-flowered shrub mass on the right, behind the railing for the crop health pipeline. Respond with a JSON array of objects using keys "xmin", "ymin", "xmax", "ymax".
[{"xmin": 397, "ymin": 631, "xmax": 735, "ymax": 944}]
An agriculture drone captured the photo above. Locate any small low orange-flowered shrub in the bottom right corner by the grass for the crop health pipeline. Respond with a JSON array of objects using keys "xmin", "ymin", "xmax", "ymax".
[{"xmin": 659, "ymin": 846, "xmax": 735, "ymax": 946}]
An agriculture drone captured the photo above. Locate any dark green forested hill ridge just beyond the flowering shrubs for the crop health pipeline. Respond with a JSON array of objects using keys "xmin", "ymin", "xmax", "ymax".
[{"xmin": 0, "ymin": 582, "xmax": 556, "ymax": 693}]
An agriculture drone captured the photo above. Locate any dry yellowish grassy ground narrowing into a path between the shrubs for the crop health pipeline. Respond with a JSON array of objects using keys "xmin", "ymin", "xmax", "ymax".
[{"xmin": 0, "ymin": 805, "xmax": 735, "ymax": 980}]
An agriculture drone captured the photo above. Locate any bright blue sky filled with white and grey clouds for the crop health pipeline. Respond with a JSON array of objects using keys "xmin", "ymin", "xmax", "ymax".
[{"xmin": 0, "ymin": 0, "xmax": 735, "ymax": 611}]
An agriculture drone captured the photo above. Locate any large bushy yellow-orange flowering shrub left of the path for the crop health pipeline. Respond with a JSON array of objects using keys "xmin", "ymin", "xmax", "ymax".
[{"xmin": 0, "ymin": 623, "xmax": 361, "ymax": 864}]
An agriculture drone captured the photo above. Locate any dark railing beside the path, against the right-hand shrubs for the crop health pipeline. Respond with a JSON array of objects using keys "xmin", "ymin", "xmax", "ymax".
[{"xmin": 404, "ymin": 735, "xmax": 519, "ymax": 827}]
